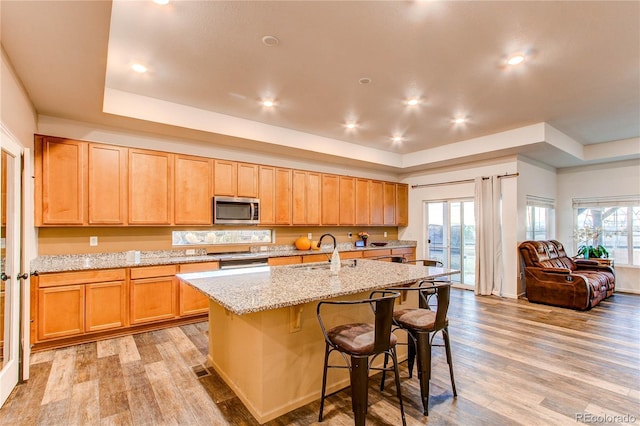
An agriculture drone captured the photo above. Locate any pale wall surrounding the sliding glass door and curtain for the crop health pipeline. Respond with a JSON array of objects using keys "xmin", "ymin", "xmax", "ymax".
[{"xmin": 398, "ymin": 156, "xmax": 519, "ymax": 298}]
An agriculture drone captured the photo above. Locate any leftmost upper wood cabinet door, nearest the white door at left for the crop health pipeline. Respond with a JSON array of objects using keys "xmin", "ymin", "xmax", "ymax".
[{"xmin": 35, "ymin": 137, "xmax": 87, "ymax": 226}]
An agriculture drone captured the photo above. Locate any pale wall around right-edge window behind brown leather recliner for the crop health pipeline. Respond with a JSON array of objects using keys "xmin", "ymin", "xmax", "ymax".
[{"xmin": 556, "ymin": 160, "xmax": 640, "ymax": 293}]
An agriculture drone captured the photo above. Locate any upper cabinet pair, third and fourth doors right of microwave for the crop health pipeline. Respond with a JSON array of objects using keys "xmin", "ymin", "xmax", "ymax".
[{"xmin": 292, "ymin": 170, "xmax": 321, "ymax": 225}]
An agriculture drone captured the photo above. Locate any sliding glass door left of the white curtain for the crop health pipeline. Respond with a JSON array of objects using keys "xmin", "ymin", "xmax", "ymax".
[{"xmin": 424, "ymin": 199, "xmax": 476, "ymax": 287}]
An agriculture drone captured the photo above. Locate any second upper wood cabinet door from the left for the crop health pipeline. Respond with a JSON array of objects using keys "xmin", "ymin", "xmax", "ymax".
[{"xmin": 88, "ymin": 143, "xmax": 129, "ymax": 225}]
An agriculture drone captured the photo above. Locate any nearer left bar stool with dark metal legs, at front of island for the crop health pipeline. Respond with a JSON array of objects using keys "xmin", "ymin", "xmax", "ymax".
[{"xmin": 316, "ymin": 290, "xmax": 406, "ymax": 426}]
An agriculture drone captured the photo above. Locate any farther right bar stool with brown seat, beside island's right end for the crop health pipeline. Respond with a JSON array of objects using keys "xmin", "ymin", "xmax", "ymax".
[{"xmin": 380, "ymin": 280, "xmax": 458, "ymax": 416}]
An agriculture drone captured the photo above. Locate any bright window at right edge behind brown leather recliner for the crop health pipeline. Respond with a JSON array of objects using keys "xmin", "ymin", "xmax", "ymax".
[{"xmin": 573, "ymin": 197, "xmax": 640, "ymax": 265}]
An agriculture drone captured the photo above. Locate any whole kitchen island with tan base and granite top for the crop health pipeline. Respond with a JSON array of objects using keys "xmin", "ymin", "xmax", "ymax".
[{"xmin": 178, "ymin": 259, "xmax": 458, "ymax": 423}]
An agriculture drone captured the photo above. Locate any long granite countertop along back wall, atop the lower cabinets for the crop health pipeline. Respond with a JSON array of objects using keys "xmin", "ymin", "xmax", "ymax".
[{"xmin": 30, "ymin": 240, "xmax": 416, "ymax": 273}]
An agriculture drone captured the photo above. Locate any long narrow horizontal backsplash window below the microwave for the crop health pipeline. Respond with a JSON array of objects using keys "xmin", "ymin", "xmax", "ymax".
[{"xmin": 172, "ymin": 229, "xmax": 275, "ymax": 246}]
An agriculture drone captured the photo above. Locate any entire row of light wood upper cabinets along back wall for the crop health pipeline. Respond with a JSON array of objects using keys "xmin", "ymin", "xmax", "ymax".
[{"xmin": 35, "ymin": 136, "xmax": 408, "ymax": 226}]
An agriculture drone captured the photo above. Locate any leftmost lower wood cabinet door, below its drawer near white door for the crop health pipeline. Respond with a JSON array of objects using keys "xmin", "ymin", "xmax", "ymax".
[{"xmin": 38, "ymin": 285, "xmax": 84, "ymax": 340}]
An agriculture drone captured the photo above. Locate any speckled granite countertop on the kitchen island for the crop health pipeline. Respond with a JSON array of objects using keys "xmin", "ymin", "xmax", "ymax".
[{"xmin": 177, "ymin": 259, "xmax": 460, "ymax": 315}]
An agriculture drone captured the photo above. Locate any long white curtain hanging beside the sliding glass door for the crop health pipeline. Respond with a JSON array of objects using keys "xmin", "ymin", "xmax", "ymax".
[{"xmin": 475, "ymin": 176, "xmax": 504, "ymax": 296}]
